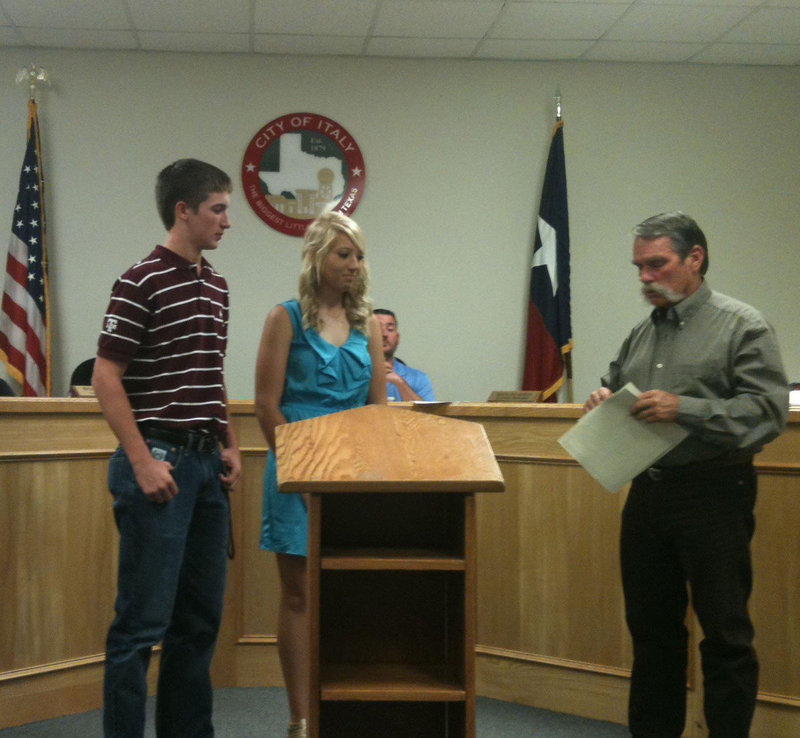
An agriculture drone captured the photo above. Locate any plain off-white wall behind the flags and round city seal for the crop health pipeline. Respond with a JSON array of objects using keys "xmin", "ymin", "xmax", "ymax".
[{"xmin": 0, "ymin": 49, "xmax": 800, "ymax": 401}]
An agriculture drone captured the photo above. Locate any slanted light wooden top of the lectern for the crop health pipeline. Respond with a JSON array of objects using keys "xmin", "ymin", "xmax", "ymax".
[{"xmin": 275, "ymin": 405, "xmax": 505, "ymax": 492}]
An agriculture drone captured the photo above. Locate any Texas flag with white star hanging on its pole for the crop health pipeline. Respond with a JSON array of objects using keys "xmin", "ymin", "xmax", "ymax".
[{"xmin": 522, "ymin": 120, "xmax": 572, "ymax": 402}]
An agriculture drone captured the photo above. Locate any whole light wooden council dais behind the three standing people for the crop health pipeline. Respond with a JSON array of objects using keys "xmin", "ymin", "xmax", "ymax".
[{"xmin": 0, "ymin": 399, "xmax": 800, "ymax": 738}]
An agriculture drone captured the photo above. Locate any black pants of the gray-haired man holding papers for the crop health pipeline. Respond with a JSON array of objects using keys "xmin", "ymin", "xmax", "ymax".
[{"xmin": 620, "ymin": 462, "xmax": 758, "ymax": 738}]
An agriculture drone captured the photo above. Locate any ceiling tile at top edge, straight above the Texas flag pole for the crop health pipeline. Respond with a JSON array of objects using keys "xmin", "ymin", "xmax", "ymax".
[{"xmin": 489, "ymin": 2, "xmax": 625, "ymax": 39}]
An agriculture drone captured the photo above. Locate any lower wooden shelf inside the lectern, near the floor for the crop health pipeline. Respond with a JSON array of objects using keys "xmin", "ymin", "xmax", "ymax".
[{"xmin": 320, "ymin": 663, "xmax": 467, "ymax": 702}]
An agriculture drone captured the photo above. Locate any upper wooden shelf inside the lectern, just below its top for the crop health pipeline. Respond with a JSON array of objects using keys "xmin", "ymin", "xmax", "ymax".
[{"xmin": 321, "ymin": 547, "xmax": 465, "ymax": 571}]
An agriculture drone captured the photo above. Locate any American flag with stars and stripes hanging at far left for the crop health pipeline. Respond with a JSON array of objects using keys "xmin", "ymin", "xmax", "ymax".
[{"xmin": 0, "ymin": 100, "xmax": 50, "ymax": 397}]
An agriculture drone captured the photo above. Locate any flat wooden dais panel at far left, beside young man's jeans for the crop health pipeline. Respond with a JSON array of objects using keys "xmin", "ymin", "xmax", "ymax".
[{"xmin": 0, "ymin": 459, "xmax": 117, "ymax": 673}]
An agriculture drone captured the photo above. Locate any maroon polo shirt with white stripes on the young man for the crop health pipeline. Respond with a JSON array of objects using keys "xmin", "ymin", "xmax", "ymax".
[{"xmin": 97, "ymin": 246, "xmax": 228, "ymax": 432}]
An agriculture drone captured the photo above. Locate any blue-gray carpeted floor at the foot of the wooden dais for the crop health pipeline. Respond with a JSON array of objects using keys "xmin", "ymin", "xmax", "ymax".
[{"xmin": 0, "ymin": 687, "xmax": 629, "ymax": 738}]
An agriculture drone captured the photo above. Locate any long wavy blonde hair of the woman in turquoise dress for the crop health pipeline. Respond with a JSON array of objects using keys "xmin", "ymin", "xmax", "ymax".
[{"xmin": 299, "ymin": 211, "xmax": 372, "ymax": 333}]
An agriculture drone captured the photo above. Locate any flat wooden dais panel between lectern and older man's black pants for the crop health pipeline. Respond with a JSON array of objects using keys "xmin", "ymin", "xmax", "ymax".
[{"xmin": 478, "ymin": 462, "xmax": 630, "ymax": 669}]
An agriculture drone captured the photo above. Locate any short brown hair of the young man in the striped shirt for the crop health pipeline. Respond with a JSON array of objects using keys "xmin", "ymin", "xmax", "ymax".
[{"xmin": 156, "ymin": 159, "xmax": 233, "ymax": 230}]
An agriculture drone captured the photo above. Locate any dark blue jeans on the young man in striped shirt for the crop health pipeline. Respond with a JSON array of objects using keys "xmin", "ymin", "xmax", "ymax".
[{"xmin": 103, "ymin": 439, "xmax": 229, "ymax": 738}]
